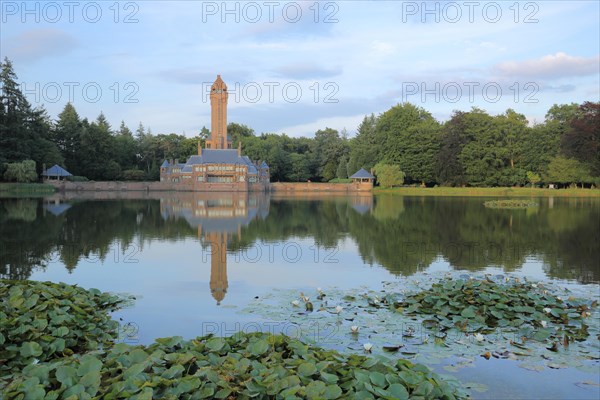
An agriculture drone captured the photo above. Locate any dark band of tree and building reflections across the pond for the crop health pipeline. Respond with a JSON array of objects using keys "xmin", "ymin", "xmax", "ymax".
[{"xmin": 0, "ymin": 193, "xmax": 600, "ymax": 282}]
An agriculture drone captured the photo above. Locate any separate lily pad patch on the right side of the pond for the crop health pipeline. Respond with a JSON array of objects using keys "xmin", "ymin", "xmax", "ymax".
[{"xmin": 393, "ymin": 278, "xmax": 597, "ymax": 343}]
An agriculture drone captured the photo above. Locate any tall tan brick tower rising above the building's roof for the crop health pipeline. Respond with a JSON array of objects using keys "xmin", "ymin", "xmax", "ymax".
[{"xmin": 206, "ymin": 75, "xmax": 231, "ymax": 149}]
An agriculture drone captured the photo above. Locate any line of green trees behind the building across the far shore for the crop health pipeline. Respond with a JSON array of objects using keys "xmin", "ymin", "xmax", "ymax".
[{"xmin": 0, "ymin": 59, "xmax": 600, "ymax": 186}]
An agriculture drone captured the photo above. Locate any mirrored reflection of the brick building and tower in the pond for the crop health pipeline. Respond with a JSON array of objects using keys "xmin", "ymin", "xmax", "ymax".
[{"xmin": 160, "ymin": 192, "xmax": 270, "ymax": 305}]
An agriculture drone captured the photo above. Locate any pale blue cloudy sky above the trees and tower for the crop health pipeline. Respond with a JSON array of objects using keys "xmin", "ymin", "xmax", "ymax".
[{"xmin": 0, "ymin": 0, "xmax": 600, "ymax": 137}]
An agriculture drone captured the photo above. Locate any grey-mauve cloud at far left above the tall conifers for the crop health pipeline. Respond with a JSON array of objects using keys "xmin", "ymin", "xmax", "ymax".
[{"xmin": 5, "ymin": 29, "xmax": 79, "ymax": 62}]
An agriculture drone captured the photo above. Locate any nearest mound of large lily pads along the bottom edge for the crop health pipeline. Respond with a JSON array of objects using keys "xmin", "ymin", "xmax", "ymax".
[{"xmin": 5, "ymin": 333, "xmax": 467, "ymax": 400}]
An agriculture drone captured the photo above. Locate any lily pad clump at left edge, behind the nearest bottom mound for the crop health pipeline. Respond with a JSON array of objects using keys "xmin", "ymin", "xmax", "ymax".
[{"xmin": 0, "ymin": 280, "xmax": 129, "ymax": 379}]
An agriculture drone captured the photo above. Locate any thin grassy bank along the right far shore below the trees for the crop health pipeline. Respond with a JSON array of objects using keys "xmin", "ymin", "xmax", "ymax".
[{"xmin": 373, "ymin": 187, "xmax": 600, "ymax": 198}]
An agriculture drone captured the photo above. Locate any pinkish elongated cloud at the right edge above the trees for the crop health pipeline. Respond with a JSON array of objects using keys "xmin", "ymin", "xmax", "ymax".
[{"xmin": 494, "ymin": 52, "xmax": 600, "ymax": 79}]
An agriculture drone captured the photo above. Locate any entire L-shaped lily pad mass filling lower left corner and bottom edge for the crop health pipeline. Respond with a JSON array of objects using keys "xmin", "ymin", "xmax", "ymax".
[{"xmin": 0, "ymin": 282, "xmax": 468, "ymax": 399}]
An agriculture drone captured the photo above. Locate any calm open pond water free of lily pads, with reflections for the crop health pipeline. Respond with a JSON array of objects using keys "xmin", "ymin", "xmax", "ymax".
[{"xmin": 0, "ymin": 193, "xmax": 600, "ymax": 398}]
